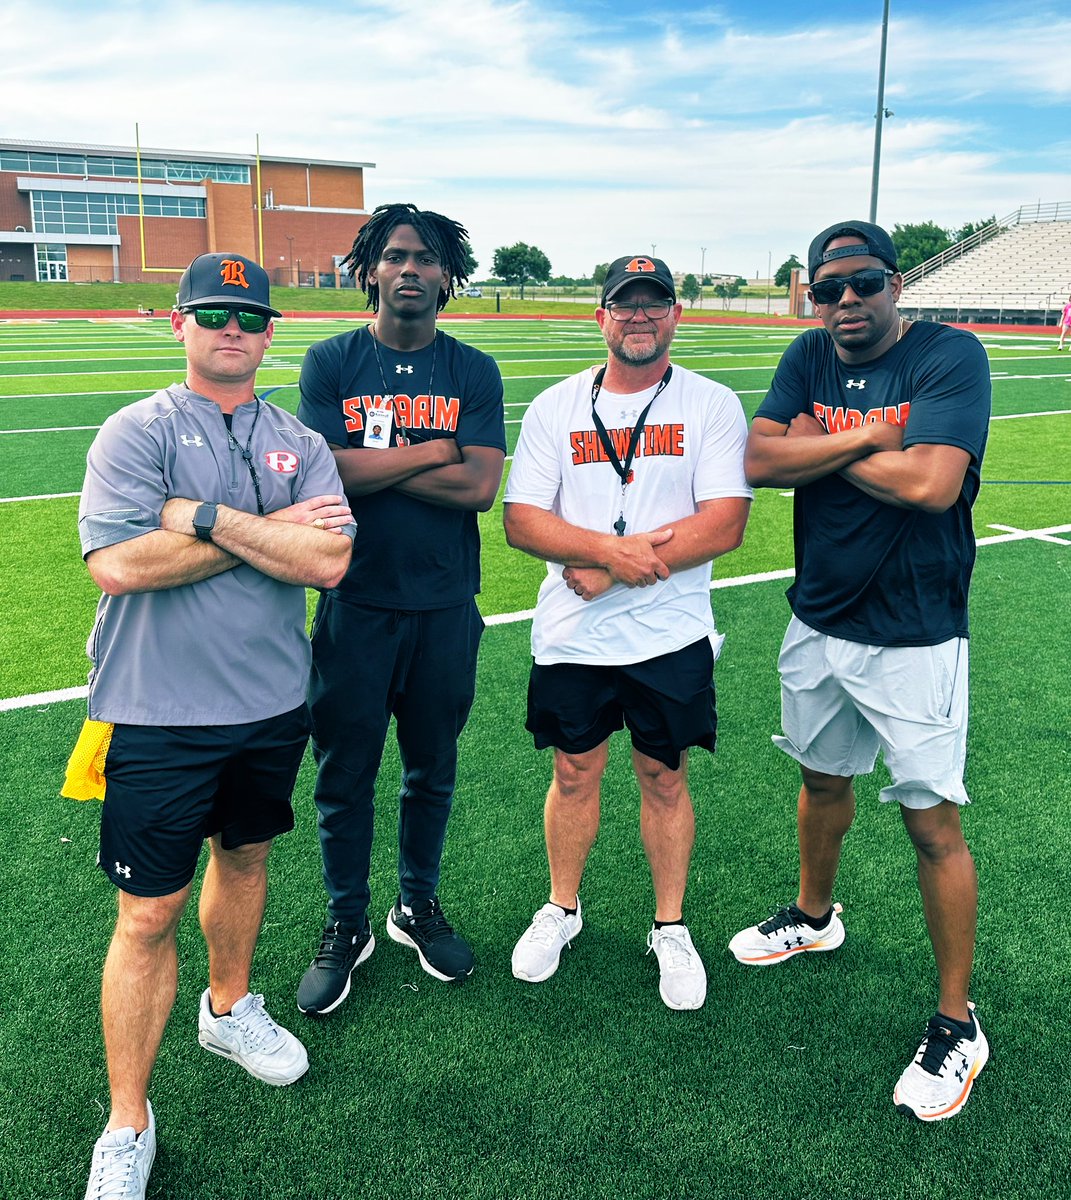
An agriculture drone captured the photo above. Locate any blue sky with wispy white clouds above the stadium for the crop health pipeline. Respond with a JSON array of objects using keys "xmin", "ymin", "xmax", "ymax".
[{"xmin": 0, "ymin": 0, "xmax": 1071, "ymax": 277}]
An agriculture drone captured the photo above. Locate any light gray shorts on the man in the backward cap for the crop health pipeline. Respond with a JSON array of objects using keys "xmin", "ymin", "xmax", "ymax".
[{"xmin": 773, "ymin": 617, "xmax": 970, "ymax": 809}]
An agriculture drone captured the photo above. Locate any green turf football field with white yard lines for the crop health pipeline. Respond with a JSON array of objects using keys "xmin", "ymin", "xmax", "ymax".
[{"xmin": 0, "ymin": 314, "xmax": 1071, "ymax": 1200}]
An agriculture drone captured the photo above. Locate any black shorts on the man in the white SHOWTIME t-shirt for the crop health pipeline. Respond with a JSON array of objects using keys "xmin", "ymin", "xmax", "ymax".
[{"xmin": 525, "ymin": 637, "xmax": 718, "ymax": 770}]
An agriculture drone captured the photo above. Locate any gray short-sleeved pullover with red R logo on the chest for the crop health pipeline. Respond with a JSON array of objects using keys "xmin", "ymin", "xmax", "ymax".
[{"xmin": 78, "ymin": 385, "xmax": 357, "ymax": 725}]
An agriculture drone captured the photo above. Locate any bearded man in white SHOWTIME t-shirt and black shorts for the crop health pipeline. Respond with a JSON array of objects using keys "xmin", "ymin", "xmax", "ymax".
[{"xmin": 505, "ymin": 256, "xmax": 752, "ymax": 1009}]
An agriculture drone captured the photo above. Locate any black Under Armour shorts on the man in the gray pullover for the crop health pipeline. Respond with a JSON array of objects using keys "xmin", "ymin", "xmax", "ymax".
[{"xmin": 98, "ymin": 704, "xmax": 309, "ymax": 896}]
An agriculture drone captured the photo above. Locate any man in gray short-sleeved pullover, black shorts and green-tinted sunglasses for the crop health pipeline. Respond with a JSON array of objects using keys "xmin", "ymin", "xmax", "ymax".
[{"xmin": 78, "ymin": 254, "xmax": 355, "ymax": 1200}]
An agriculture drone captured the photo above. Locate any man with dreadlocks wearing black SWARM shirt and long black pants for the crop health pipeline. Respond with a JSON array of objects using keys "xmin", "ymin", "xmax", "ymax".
[{"xmin": 298, "ymin": 204, "xmax": 505, "ymax": 1015}]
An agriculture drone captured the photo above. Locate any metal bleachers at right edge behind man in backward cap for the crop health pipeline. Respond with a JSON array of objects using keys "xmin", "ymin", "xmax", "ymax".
[{"xmin": 899, "ymin": 203, "xmax": 1071, "ymax": 324}]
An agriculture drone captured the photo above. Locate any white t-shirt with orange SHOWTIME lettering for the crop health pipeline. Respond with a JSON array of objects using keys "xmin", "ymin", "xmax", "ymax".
[{"xmin": 505, "ymin": 366, "xmax": 753, "ymax": 666}]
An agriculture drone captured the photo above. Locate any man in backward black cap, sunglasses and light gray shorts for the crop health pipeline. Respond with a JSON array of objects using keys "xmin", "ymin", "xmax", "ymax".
[{"xmin": 729, "ymin": 221, "xmax": 991, "ymax": 1121}]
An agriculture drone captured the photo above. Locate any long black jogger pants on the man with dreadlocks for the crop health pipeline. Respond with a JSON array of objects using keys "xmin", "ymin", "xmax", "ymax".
[{"xmin": 309, "ymin": 595, "xmax": 484, "ymax": 924}]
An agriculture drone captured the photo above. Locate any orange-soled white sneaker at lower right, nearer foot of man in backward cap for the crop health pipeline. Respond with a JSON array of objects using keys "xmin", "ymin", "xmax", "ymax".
[{"xmin": 892, "ymin": 1004, "xmax": 989, "ymax": 1121}]
